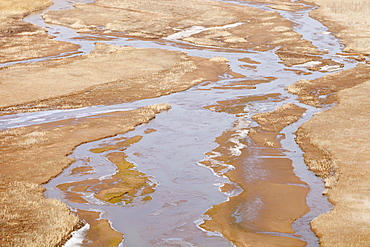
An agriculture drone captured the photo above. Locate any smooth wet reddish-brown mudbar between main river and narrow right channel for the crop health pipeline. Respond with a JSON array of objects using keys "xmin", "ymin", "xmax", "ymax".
[{"xmin": 201, "ymin": 100, "xmax": 309, "ymax": 246}]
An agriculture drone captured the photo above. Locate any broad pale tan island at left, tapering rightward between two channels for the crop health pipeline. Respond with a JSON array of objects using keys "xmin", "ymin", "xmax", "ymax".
[{"xmin": 0, "ymin": 43, "xmax": 228, "ymax": 114}]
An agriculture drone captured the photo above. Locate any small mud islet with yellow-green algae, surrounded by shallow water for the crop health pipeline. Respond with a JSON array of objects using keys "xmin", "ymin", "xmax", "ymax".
[{"xmin": 58, "ymin": 135, "xmax": 156, "ymax": 205}]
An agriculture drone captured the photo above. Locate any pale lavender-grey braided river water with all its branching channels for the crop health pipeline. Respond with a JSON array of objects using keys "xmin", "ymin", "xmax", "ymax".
[{"xmin": 0, "ymin": 0, "xmax": 356, "ymax": 247}]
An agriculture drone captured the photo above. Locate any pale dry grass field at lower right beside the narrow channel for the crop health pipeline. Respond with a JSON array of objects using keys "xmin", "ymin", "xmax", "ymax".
[{"xmin": 297, "ymin": 81, "xmax": 370, "ymax": 246}]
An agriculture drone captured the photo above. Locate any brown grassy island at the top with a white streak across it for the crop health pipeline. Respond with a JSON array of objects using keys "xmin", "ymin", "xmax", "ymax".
[{"xmin": 43, "ymin": 0, "xmax": 326, "ymax": 66}]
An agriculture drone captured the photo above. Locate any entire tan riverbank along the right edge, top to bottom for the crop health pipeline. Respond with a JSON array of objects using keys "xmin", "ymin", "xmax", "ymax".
[{"xmin": 288, "ymin": 0, "xmax": 370, "ymax": 246}]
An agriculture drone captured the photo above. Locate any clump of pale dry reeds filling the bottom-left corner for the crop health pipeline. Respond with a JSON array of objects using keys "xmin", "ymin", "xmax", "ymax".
[{"xmin": 0, "ymin": 181, "xmax": 79, "ymax": 247}]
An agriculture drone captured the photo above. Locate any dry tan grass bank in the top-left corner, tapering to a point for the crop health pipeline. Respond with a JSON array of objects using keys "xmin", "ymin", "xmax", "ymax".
[{"xmin": 0, "ymin": 0, "xmax": 79, "ymax": 63}]
